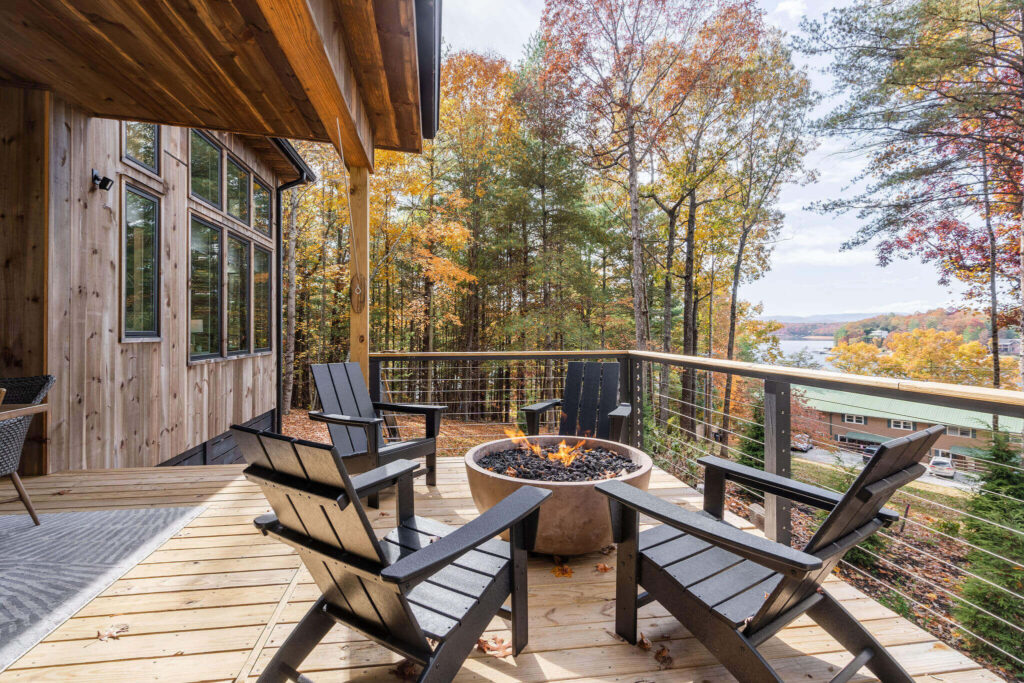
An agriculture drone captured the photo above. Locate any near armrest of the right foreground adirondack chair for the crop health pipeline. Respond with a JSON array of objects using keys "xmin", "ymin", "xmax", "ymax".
[{"xmin": 597, "ymin": 481, "xmax": 821, "ymax": 577}]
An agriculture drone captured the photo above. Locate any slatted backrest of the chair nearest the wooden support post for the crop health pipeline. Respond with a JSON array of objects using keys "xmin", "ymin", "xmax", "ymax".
[{"xmin": 310, "ymin": 362, "xmax": 384, "ymax": 456}]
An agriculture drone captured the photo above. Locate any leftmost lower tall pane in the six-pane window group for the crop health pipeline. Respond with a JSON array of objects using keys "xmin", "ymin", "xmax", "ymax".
[{"xmin": 188, "ymin": 216, "xmax": 220, "ymax": 358}]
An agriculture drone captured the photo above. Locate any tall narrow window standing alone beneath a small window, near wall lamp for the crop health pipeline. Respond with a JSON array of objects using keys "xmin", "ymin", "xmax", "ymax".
[{"xmin": 122, "ymin": 185, "xmax": 160, "ymax": 337}]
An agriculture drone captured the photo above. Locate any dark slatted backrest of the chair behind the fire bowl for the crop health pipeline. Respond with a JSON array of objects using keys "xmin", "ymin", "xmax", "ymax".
[{"xmin": 558, "ymin": 360, "xmax": 618, "ymax": 438}]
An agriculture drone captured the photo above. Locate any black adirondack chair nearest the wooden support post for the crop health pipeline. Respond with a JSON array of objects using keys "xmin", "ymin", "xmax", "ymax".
[{"xmin": 309, "ymin": 362, "xmax": 447, "ymax": 508}]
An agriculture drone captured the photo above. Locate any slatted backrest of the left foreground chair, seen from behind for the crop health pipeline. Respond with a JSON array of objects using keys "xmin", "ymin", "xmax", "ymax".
[{"xmin": 231, "ymin": 427, "xmax": 430, "ymax": 653}]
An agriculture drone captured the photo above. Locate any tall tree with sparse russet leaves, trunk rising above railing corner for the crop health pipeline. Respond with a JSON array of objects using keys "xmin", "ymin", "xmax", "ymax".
[{"xmin": 542, "ymin": 0, "xmax": 717, "ymax": 349}]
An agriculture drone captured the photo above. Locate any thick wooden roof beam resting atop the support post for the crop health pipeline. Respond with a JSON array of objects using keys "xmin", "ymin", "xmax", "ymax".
[{"xmin": 243, "ymin": 0, "xmax": 374, "ymax": 168}]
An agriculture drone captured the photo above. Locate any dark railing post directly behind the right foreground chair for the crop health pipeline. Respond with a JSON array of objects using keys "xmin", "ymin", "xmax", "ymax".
[{"xmin": 765, "ymin": 380, "xmax": 793, "ymax": 545}]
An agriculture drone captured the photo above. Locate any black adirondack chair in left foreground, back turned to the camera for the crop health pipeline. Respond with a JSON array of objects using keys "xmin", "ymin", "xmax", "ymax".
[{"xmin": 231, "ymin": 426, "xmax": 551, "ymax": 682}]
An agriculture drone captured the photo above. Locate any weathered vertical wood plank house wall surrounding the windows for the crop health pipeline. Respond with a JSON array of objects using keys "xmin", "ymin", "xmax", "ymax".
[{"xmin": 0, "ymin": 93, "xmax": 279, "ymax": 473}]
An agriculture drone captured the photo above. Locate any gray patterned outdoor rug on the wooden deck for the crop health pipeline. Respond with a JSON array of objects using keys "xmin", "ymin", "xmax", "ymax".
[{"xmin": 0, "ymin": 507, "xmax": 204, "ymax": 672}]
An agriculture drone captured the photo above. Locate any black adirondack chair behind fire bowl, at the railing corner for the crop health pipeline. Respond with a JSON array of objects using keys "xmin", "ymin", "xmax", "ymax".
[{"xmin": 522, "ymin": 360, "xmax": 632, "ymax": 441}]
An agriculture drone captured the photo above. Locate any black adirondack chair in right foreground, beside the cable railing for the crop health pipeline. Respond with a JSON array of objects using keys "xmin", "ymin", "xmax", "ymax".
[{"xmin": 597, "ymin": 425, "xmax": 944, "ymax": 683}]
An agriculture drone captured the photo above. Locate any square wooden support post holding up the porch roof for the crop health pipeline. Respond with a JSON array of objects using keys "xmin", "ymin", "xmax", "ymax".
[{"xmin": 348, "ymin": 167, "xmax": 370, "ymax": 381}]
